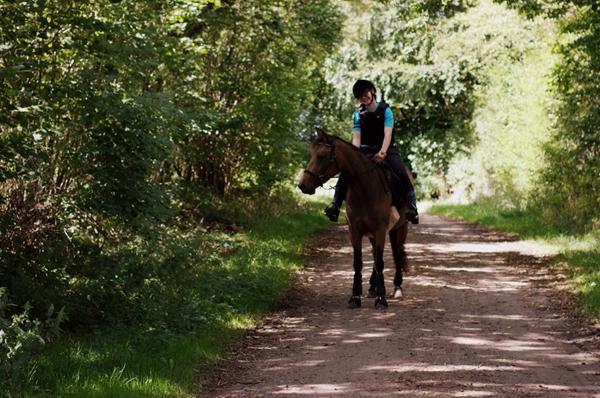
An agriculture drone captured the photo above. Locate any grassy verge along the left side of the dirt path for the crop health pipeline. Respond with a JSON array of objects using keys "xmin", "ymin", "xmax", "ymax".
[{"xmin": 7, "ymin": 204, "xmax": 327, "ymax": 397}]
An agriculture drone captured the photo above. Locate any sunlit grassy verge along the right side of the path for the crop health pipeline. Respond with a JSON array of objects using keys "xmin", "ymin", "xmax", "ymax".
[{"xmin": 429, "ymin": 203, "xmax": 600, "ymax": 319}]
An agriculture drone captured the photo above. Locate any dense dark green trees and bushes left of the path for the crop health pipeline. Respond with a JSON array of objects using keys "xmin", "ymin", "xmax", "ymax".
[{"xmin": 0, "ymin": 0, "xmax": 341, "ymax": 390}]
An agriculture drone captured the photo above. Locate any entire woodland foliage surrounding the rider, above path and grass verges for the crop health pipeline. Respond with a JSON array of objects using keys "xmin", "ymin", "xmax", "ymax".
[{"xmin": 0, "ymin": 0, "xmax": 600, "ymax": 386}]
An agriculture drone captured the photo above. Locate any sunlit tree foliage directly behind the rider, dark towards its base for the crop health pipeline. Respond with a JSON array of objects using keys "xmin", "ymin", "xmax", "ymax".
[{"xmin": 328, "ymin": 0, "xmax": 477, "ymax": 176}]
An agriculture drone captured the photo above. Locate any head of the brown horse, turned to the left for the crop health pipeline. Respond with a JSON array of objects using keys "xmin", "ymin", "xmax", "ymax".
[{"xmin": 298, "ymin": 129, "xmax": 340, "ymax": 195}]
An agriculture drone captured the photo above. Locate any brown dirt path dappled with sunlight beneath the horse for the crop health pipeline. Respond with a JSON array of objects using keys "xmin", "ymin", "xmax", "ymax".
[{"xmin": 203, "ymin": 215, "xmax": 600, "ymax": 398}]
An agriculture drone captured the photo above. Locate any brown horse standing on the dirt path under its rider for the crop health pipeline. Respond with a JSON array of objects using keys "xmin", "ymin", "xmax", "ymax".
[{"xmin": 298, "ymin": 129, "xmax": 408, "ymax": 308}]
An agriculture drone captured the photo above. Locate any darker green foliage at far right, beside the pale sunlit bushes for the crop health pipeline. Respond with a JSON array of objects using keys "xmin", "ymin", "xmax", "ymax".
[{"xmin": 496, "ymin": 0, "xmax": 600, "ymax": 230}]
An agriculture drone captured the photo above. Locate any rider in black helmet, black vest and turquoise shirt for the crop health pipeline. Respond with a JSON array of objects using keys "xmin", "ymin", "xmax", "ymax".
[{"xmin": 325, "ymin": 79, "xmax": 419, "ymax": 224}]
